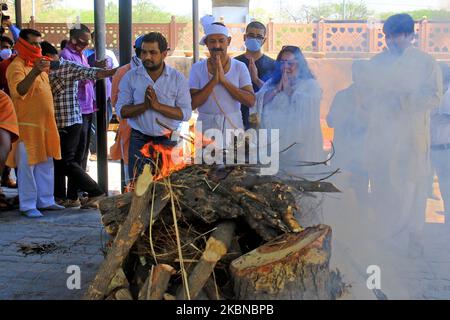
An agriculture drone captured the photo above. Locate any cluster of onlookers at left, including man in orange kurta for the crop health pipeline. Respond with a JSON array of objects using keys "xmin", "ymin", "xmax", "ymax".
[{"xmin": 0, "ymin": 19, "xmax": 118, "ymax": 218}]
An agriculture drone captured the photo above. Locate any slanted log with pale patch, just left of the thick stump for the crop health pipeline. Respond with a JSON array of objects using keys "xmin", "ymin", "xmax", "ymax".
[{"xmin": 177, "ymin": 221, "xmax": 236, "ymax": 300}]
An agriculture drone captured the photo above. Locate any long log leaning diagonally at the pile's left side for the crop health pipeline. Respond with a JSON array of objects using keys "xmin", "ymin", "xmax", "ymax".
[{"xmin": 85, "ymin": 165, "xmax": 169, "ymax": 299}]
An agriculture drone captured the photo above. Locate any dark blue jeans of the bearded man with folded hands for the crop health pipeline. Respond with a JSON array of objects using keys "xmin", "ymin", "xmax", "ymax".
[{"xmin": 128, "ymin": 129, "xmax": 176, "ymax": 181}]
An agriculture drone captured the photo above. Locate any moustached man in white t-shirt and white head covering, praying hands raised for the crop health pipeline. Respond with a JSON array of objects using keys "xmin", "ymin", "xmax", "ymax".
[{"xmin": 189, "ymin": 16, "xmax": 255, "ymax": 137}]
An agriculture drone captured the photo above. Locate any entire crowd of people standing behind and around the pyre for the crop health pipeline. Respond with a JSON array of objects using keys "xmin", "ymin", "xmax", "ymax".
[{"xmin": 0, "ymin": 14, "xmax": 450, "ymax": 298}]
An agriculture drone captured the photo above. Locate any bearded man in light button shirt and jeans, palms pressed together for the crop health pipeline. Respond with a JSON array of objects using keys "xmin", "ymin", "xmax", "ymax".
[{"xmin": 116, "ymin": 32, "xmax": 192, "ymax": 180}]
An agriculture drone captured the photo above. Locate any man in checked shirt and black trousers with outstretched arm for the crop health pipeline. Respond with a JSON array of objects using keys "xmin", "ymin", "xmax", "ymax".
[{"xmin": 41, "ymin": 41, "xmax": 117, "ymax": 208}]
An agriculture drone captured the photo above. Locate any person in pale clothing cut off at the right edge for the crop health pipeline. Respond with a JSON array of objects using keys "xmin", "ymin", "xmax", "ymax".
[{"xmin": 430, "ymin": 65, "xmax": 450, "ymax": 216}]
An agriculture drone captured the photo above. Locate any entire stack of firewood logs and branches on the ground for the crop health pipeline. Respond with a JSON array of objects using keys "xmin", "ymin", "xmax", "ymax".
[{"xmin": 86, "ymin": 165, "xmax": 343, "ymax": 300}]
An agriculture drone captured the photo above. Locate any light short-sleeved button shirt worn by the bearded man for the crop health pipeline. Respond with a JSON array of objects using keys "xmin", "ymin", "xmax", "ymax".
[{"xmin": 116, "ymin": 64, "xmax": 192, "ymax": 136}]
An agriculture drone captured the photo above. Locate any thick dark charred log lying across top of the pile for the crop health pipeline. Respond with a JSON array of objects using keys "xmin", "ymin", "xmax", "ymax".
[{"xmin": 100, "ymin": 166, "xmax": 338, "ymax": 241}]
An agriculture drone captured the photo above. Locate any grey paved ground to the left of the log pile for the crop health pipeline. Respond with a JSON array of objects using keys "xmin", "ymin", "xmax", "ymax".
[{"xmin": 0, "ymin": 209, "xmax": 106, "ymax": 299}]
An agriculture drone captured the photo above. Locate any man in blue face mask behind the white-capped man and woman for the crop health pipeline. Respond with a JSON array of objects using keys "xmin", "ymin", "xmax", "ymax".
[{"xmin": 235, "ymin": 21, "xmax": 275, "ymax": 130}]
